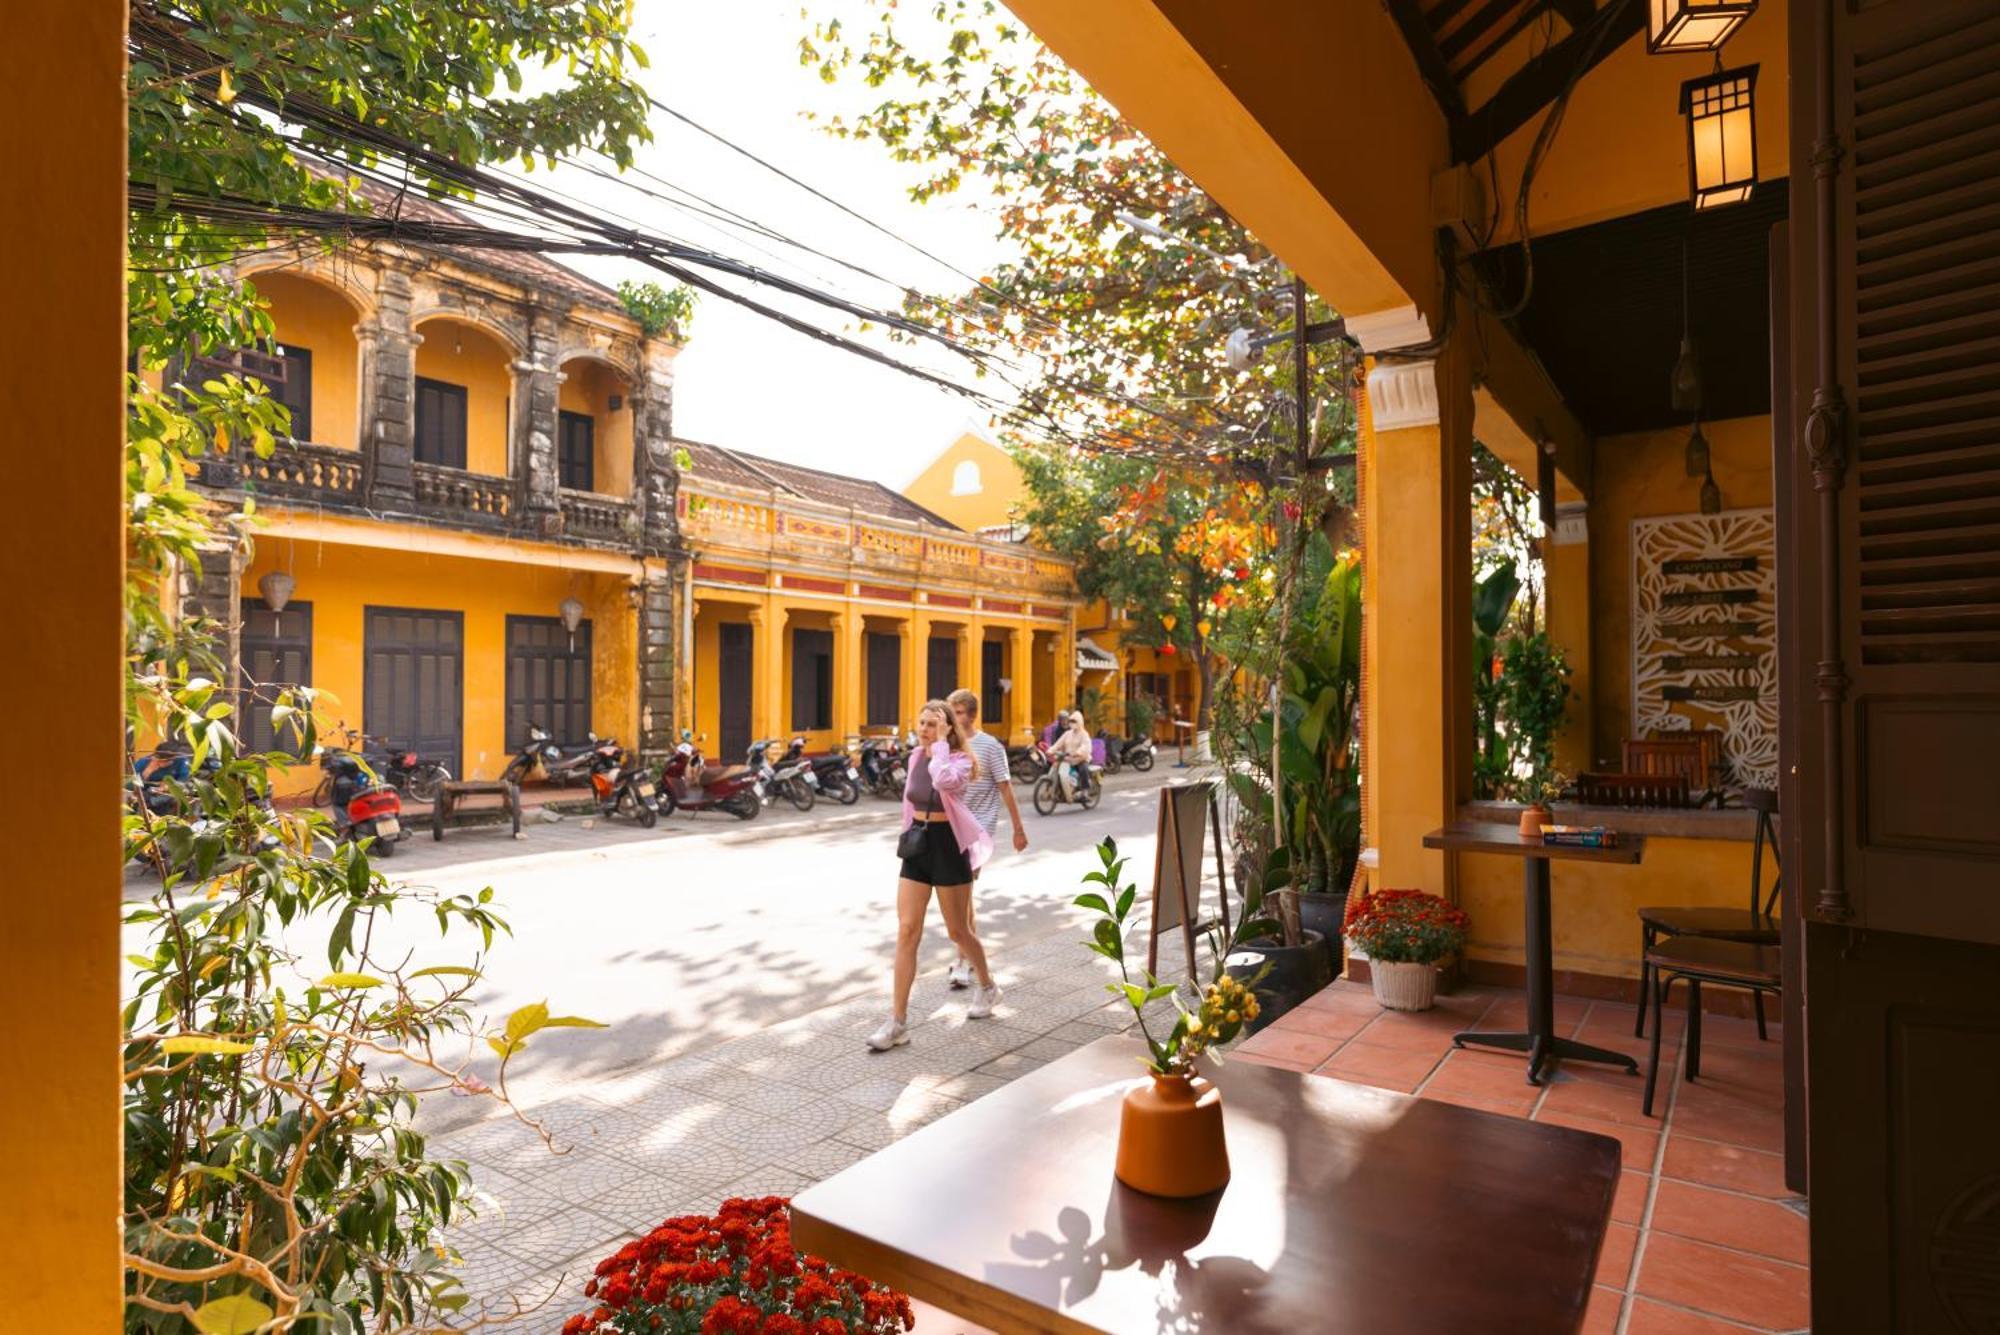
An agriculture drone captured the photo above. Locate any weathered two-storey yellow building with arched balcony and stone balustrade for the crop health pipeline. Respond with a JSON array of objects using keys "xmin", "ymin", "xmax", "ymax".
[{"xmin": 192, "ymin": 193, "xmax": 682, "ymax": 787}]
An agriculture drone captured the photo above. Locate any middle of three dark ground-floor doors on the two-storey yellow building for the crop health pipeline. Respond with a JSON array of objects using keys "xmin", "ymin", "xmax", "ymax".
[{"xmin": 362, "ymin": 608, "xmax": 466, "ymax": 773}]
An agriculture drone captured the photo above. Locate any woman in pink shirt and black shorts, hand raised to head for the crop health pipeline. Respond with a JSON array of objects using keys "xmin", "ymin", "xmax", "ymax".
[{"xmin": 868, "ymin": 699, "xmax": 1000, "ymax": 1051}]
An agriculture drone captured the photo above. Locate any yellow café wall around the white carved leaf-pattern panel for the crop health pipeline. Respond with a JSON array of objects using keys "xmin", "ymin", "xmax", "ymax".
[{"xmin": 1590, "ymin": 418, "xmax": 1772, "ymax": 767}]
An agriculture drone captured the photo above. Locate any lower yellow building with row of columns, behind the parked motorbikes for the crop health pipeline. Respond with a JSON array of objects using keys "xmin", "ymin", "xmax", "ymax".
[{"xmin": 680, "ymin": 433, "xmax": 1076, "ymax": 761}]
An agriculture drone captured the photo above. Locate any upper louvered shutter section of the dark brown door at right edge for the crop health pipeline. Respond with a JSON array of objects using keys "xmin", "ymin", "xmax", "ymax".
[{"xmin": 1806, "ymin": 0, "xmax": 2000, "ymax": 941}]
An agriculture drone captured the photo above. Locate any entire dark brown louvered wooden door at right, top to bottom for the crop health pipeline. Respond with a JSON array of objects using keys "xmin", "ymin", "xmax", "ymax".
[{"xmin": 1780, "ymin": 0, "xmax": 2000, "ymax": 1335}]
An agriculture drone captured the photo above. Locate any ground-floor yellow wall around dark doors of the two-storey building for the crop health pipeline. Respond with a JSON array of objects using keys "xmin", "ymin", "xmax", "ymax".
[{"xmin": 244, "ymin": 538, "xmax": 638, "ymax": 791}]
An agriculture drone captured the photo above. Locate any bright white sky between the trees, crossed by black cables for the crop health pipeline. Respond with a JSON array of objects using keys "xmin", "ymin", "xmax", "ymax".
[{"xmin": 542, "ymin": 0, "xmax": 1004, "ymax": 488}]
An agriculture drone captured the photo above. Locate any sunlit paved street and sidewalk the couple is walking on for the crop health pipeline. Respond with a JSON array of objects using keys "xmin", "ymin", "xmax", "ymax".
[{"xmin": 386, "ymin": 765, "xmax": 1184, "ymax": 1329}]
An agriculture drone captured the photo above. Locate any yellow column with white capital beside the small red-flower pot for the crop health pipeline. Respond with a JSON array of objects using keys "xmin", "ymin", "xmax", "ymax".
[{"xmin": 1362, "ymin": 331, "xmax": 1472, "ymax": 893}]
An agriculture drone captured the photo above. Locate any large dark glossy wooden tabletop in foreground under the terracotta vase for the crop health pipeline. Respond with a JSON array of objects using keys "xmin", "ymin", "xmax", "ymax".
[{"xmin": 792, "ymin": 1031, "xmax": 1620, "ymax": 1335}]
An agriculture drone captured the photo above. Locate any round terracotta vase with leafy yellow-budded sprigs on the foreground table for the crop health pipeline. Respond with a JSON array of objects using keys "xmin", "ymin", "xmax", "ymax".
[{"xmin": 1076, "ymin": 839, "xmax": 1276, "ymax": 1197}]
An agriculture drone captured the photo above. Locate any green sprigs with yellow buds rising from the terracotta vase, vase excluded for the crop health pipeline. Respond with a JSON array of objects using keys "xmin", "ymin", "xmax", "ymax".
[{"xmin": 1074, "ymin": 837, "xmax": 1278, "ymax": 1075}]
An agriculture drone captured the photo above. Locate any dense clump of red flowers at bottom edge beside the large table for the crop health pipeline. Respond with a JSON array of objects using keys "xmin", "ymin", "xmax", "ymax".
[{"xmin": 562, "ymin": 1195, "xmax": 916, "ymax": 1335}]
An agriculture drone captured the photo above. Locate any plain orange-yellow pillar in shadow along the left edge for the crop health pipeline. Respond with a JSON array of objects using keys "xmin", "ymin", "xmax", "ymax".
[{"xmin": 0, "ymin": 0, "xmax": 126, "ymax": 1331}]
